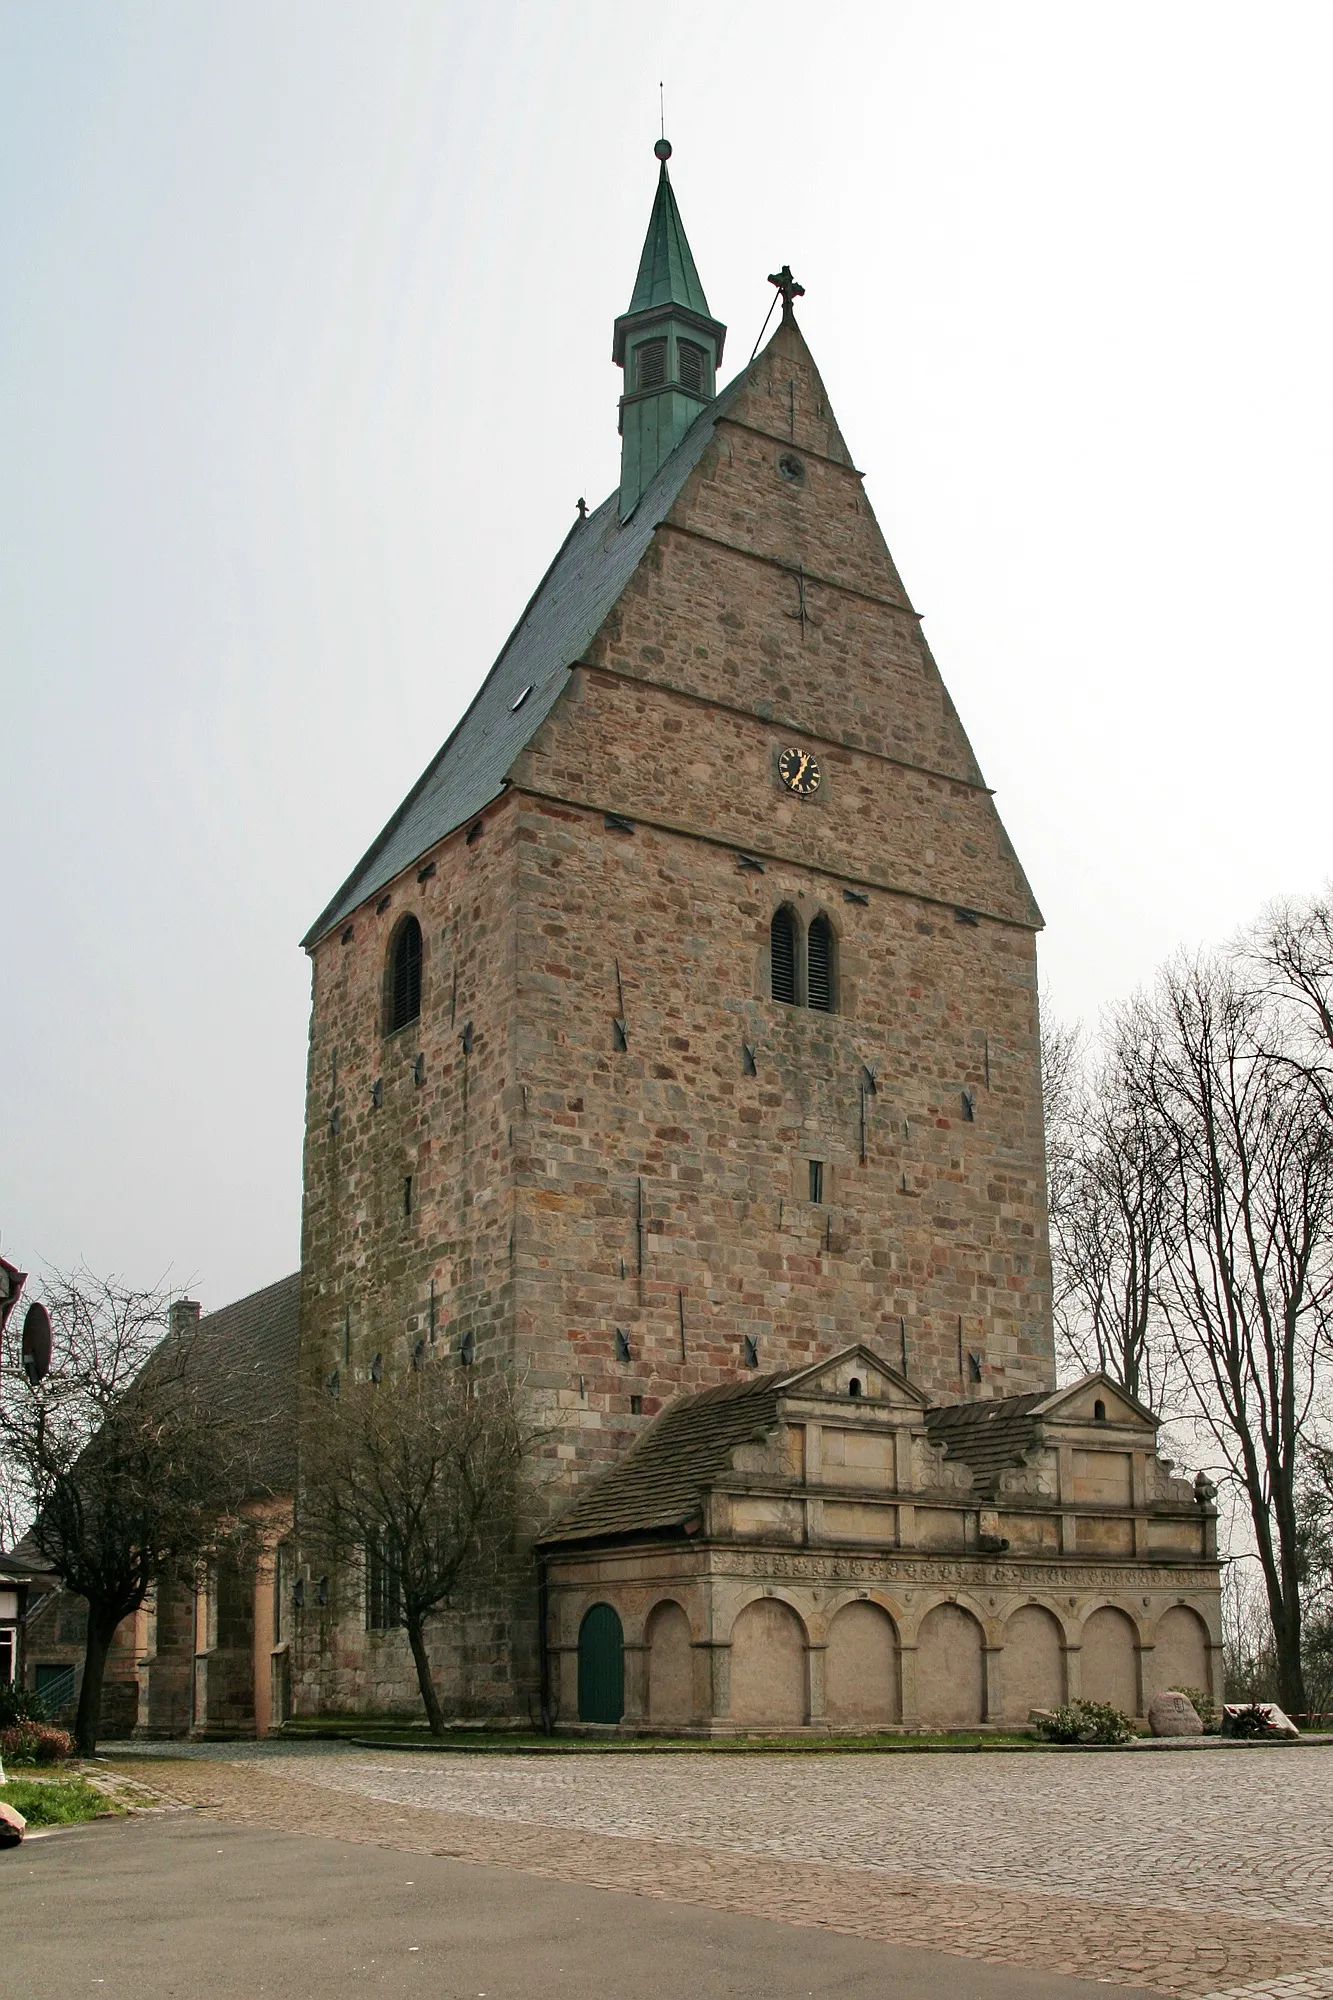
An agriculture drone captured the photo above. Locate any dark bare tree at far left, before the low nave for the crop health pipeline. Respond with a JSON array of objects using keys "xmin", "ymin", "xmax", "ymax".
[{"xmin": 0, "ymin": 1272, "xmax": 254, "ymax": 1756}]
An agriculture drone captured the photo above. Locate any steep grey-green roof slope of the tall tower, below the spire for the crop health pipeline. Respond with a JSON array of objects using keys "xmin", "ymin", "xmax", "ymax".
[{"xmin": 300, "ymin": 370, "xmax": 749, "ymax": 948}]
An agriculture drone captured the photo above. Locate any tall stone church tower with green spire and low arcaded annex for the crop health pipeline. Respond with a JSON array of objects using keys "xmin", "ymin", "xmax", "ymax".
[{"xmin": 288, "ymin": 142, "xmax": 1221, "ymax": 1732}]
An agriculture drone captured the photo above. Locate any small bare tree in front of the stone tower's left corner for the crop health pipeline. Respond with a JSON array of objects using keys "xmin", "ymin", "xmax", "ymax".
[{"xmin": 298, "ymin": 1358, "xmax": 536, "ymax": 1736}]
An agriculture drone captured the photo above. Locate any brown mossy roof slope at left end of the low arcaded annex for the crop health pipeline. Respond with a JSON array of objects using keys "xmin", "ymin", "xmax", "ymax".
[{"xmin": 542, "ymin": 1370, "xmax": 791, "ymax": 1546}]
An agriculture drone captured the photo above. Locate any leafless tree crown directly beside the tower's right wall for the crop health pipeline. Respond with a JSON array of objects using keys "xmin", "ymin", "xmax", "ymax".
[{"xmin": 1043, "ymin": 1010, "xmax": 1169, "ymax": 1402}]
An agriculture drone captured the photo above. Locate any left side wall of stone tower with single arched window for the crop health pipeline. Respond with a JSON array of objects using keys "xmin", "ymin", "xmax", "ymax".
[{"xmin": 292, "ymin": 802, "xmax": 532, "ymax": 1712}]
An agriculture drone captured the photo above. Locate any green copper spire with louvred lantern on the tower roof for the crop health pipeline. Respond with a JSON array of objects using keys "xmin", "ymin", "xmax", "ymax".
[{"xmin": 610, "ymin": 138, "xmax": 727, "ymax": 520}]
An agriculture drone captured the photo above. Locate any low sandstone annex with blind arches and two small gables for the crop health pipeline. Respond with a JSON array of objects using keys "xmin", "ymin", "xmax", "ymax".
[{"xmin": 538, "ymin": 1346, "xmax": 1221, "ymax": 1734}]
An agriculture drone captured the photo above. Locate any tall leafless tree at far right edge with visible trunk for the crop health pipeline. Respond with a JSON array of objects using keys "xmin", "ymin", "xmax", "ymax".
[{"xmin": 1121, "ymin": 956, "xmax": 1333, "ymax": 1712}]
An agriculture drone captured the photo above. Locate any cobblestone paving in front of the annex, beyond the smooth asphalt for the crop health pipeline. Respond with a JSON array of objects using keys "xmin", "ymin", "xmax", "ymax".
[{"xmin": 106, "ymin": 1744, "xmax": 1333, "ymax": 2000}]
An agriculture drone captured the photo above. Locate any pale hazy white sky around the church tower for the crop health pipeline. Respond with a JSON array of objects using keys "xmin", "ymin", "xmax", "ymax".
[{"xmin": 0, "ymin": 0, "xmax": 1333, "ymax": 1308}]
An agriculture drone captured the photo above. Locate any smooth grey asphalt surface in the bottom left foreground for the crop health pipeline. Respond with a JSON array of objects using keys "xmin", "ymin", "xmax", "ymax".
[{"xmin": 0, "ymin": 1814, "xmax": 1143, "ymax": 2000}]
